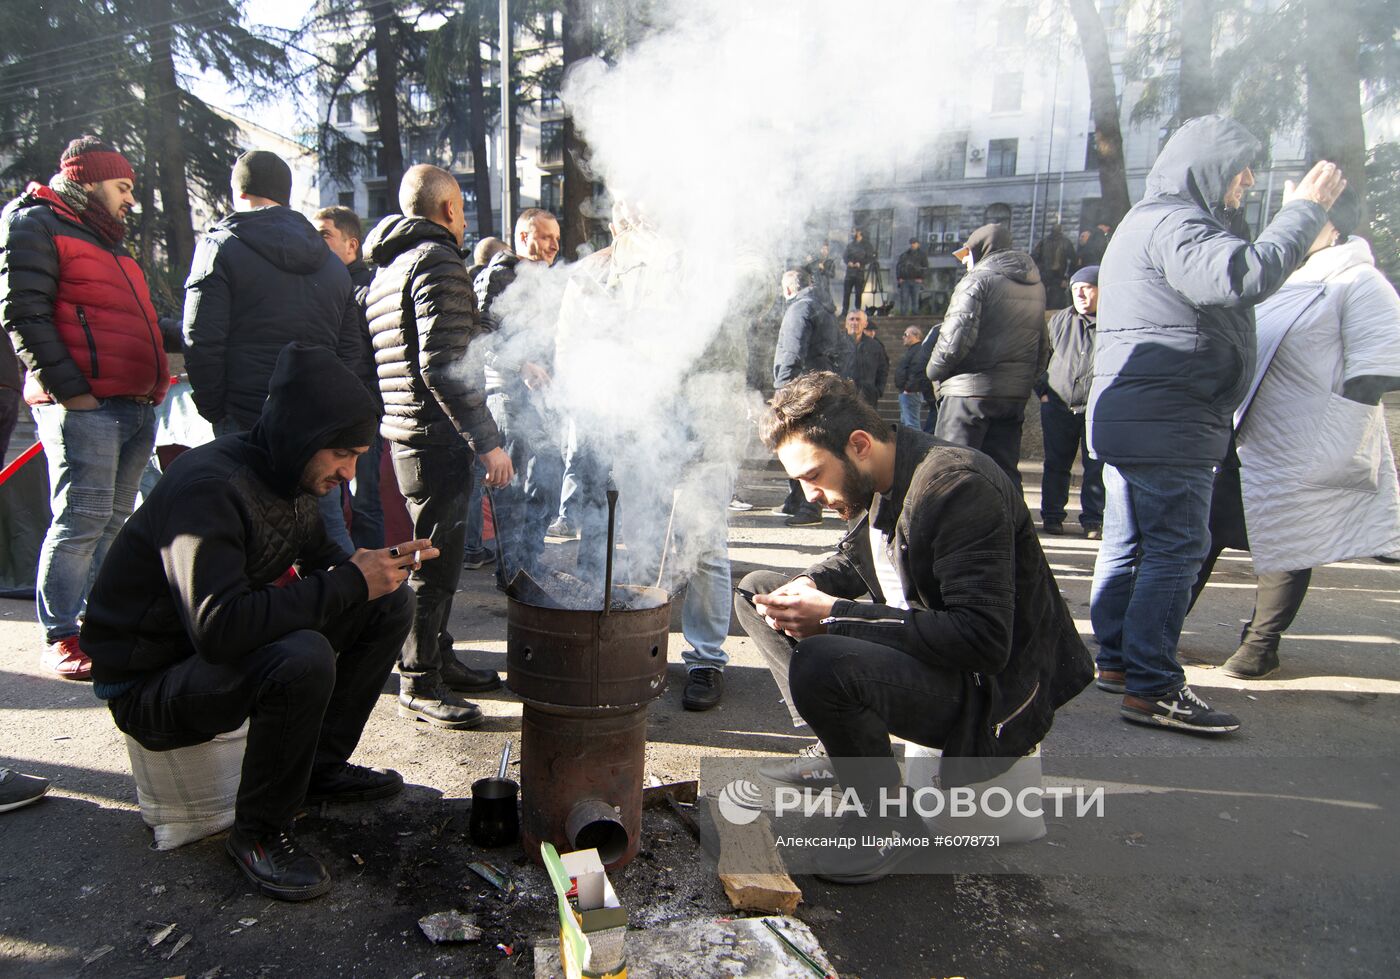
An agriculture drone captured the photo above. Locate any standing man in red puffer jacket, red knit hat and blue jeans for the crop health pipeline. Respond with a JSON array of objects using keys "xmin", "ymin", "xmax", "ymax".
[{"xmin": 0, "ymin": 136, "xmax": 169, "ymax": 679}]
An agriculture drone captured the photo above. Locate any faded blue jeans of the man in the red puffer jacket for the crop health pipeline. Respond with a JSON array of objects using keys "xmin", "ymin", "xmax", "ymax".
[{"xmin": 34, "ymin": 398, "xmax": 155, "ymax": 643}]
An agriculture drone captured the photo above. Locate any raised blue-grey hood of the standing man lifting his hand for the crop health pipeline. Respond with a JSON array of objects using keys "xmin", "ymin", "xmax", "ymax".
[{"xmin": 1147, "ymin": 116, "xmax": 1260, "ymax": 213}]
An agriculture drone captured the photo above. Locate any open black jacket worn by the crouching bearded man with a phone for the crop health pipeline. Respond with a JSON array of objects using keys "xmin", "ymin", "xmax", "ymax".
[{"xmin": 805, "ymin": 426, "xmax": 1093, "ymax": 759}]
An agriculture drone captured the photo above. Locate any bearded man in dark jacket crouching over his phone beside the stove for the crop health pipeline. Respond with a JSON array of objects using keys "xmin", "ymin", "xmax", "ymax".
[{"xmin": 735, "ymin": 373, "xmax": 1093, "ymax": 882}]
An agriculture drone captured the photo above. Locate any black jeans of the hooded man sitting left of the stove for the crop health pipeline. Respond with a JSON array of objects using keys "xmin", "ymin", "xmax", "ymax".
[{"xmin": 108, "ymin": 588, "xmax": 413, "ymax": 833}]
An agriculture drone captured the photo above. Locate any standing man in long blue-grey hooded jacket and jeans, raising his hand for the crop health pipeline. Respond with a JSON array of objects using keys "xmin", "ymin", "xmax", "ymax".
[{"xmin": 1088, "ymin": 116, "xmax": 1345, "ymax": 734}]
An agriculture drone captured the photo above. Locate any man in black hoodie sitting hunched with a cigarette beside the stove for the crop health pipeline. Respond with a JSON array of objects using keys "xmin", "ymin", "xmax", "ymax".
[{"xmin": 81, "ymin": 343, "xmax": 437, "ymax": 901}]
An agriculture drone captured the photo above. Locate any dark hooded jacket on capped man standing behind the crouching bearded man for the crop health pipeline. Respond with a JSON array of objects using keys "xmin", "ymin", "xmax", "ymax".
[{"xmin": 927, "ymin": 234, "xmax": 1050, "ymax": 401}]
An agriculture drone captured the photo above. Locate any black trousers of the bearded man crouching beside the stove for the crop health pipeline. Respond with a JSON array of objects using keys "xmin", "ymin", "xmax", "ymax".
[{"xmin": 735, "ymin": 571, "xmax": 963, "ymax": 800}]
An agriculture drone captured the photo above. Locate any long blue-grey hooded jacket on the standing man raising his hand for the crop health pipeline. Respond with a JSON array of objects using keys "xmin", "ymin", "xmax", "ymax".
[{"xmin": 1088, "ymin": 116, "xmax": 1327, "ymax": 465}]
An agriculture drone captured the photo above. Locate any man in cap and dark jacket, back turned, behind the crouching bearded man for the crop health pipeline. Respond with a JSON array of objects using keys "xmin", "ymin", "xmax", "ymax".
[{"xmin": 927, "ymin": 224, "xmax": 1050, "ymax": 486}]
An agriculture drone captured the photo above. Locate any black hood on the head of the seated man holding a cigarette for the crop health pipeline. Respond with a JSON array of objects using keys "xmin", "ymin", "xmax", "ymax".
[{"xmin": 246, "ymin": 344, "xmax": 379, "ymax": 496}]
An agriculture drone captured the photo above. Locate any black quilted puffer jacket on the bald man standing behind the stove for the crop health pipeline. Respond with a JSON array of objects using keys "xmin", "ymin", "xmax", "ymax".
[{"xmin": 364, "ymin": 214, "xmax": 501, "ymax": 455}]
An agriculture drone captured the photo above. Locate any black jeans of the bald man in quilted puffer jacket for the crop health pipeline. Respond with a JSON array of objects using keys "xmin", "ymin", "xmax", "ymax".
[{"xmin": 392, "ymin": 443, "xmax": 475, "ymax": 676}]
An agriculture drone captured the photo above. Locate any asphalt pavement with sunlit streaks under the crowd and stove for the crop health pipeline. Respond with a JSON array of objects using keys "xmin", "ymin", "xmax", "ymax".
[{"xmin": 0, "ymin": 464, "xmax": 1400, "ymax": 979}]
